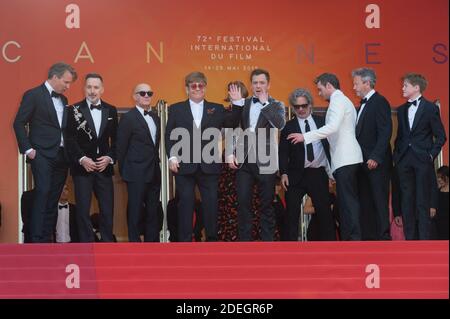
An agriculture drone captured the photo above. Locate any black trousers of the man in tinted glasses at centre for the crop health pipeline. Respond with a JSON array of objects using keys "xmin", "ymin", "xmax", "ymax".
[{"xmin": 175, "ymin": 167, "xmax": 219, "ymax": 242}]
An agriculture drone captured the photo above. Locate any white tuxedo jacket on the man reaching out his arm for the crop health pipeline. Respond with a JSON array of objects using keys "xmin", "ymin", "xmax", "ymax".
[{"xmin": 303, "ymin": 90, "xmax": 363, "ymax": 172}]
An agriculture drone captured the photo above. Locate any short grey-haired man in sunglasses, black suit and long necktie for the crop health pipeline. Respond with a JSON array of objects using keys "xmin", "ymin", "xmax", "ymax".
[{"xmin": 279, "ymin": 89, "xmax": 336, "ymax": 241}]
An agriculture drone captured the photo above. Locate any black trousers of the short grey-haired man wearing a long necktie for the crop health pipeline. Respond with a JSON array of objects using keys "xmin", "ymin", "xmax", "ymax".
[{"xmin": 286, "ymin": 167, "xmax": 336, "ymax": 241}]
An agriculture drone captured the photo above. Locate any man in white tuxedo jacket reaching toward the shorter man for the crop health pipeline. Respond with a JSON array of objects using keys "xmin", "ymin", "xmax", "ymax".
[{"xmin": 287, "ymin": 73, "xmax": 363, "ymax": 240}]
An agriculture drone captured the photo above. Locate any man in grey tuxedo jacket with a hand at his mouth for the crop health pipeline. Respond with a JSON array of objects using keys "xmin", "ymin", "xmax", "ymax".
[{"xmin": 227, "ymin": 69, "xmax": 286, "ymax": 241}]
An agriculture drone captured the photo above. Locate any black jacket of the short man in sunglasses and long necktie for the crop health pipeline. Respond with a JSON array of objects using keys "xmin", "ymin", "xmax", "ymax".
[{"xmin": 279, "ymin": 115, "xmax": 330, "ymax": 185}]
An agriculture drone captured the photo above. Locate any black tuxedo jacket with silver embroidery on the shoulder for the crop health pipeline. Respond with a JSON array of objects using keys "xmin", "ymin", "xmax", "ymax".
[{"xmin": 64, "ymin": 100, "xmax": 118, "ymax": 176}]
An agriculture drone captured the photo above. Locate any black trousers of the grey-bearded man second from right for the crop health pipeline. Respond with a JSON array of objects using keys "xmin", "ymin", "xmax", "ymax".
[{"xmin": 358, "ymin": 163, "xmax": 391, "ymax": 240}]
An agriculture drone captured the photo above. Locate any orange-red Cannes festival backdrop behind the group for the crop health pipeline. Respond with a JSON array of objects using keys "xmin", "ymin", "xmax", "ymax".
[{"xmin": 0, "ymin": 0, "xmax": 449, "ymax": 242}]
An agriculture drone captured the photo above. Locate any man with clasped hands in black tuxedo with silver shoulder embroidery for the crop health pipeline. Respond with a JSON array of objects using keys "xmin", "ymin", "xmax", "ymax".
[{"xmin": 65, "ymin": 73, "xmax": 117, "ymax": 243}]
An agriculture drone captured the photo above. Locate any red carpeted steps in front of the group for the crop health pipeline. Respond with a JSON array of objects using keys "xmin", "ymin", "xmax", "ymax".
[{"xmin": 0, "ymin": 241, "xmax": 449, "ymax": 299}]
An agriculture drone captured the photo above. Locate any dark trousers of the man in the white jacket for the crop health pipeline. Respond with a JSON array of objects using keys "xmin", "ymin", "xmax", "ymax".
[{"xmin": 334, "ymin": 163, "xmax": 362, "ymax": 240}]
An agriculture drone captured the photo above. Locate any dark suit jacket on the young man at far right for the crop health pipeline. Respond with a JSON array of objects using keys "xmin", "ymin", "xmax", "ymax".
[{"xmin": 394, "ymin": 96, "xmax": 447, "ymax": 164}]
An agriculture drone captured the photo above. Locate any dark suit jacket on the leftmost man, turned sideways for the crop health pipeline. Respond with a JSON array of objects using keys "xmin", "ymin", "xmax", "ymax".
[{"xmin": 13, "ymin": 84, "xmax": 67, "ymax": 158}]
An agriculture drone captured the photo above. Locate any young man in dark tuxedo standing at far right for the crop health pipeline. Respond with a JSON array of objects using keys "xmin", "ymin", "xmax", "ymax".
[{"xmin": 394, "ymin": 73, "xmax": 447, "ymax": 240}]
